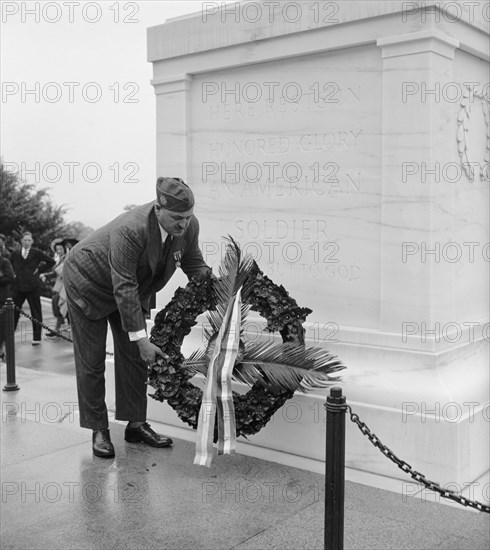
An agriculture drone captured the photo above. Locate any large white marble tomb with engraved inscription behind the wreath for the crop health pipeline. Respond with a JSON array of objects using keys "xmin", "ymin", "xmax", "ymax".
[{"xmin": 143, "ymin": 1, "xmax": 490, "ymax": 487}]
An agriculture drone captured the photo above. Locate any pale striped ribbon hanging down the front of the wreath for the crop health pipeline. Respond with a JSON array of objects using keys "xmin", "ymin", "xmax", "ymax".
[{"xmin": 194, "ymin": 289, "xmax": 241, "ymax": 467}]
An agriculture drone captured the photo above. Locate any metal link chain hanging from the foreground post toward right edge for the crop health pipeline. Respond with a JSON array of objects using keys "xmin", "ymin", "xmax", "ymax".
[{"xmin": 325, "ymin": 402, "xmax": 490, "ymax": 514}]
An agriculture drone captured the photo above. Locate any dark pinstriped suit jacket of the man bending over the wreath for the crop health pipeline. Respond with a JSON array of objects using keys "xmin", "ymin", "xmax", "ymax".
[{"xmin": 63, "ymin": 202, "xmax": 210, "ymax": 332}]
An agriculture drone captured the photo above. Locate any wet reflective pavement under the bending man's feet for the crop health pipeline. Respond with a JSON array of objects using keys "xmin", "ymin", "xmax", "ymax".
[{"xmin": 0, "ymin": 304, "xmax": 490, "ymax": 550}]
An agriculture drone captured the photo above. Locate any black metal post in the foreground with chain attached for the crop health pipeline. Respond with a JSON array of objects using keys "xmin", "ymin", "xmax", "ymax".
[{"xmin": 325, "ymin": 387, "xmax": 347, "ymax": 550}]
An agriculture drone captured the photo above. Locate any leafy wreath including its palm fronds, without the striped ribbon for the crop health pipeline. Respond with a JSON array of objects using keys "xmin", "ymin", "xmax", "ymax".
[{"xmin": 148, "ymin": 237, "xmax": 345, "ymax": 440}]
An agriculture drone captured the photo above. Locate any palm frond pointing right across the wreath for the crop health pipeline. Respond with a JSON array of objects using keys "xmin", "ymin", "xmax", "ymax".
[{"xmin": 233, "ymin": 342, "xmax": 345, "ymax": 391}]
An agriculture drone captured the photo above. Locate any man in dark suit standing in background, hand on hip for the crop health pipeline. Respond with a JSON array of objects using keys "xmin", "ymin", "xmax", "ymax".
[{"xmin": 10, "ymin": 231, "xmax": 55, "ymax": 346}]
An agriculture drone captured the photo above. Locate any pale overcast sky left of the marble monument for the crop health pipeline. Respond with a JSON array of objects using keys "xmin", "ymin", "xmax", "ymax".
[{"xmin": 0, "ymin": 0, "xmax": 212, "ymax": 228}]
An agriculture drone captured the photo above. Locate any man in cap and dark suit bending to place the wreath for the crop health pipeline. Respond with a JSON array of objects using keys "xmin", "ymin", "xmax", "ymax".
[{"xmin": 63, "ymin": 178, "xmax": 210, "ymax": 458}]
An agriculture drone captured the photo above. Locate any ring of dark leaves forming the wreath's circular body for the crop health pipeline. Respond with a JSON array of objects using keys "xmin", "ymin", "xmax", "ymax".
[{"xmin": 148, "ymin": 250, "xmax": 345, "ymax": 442}]
